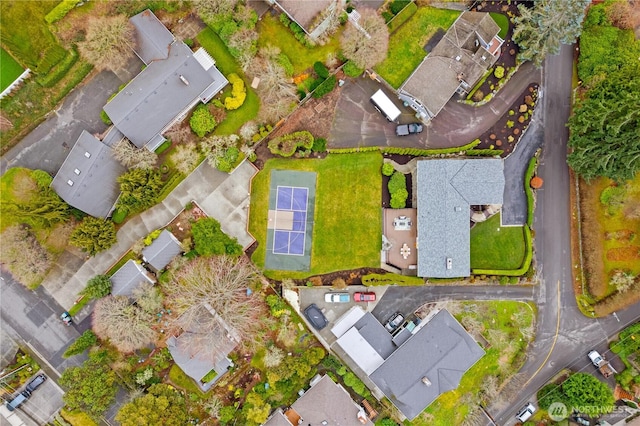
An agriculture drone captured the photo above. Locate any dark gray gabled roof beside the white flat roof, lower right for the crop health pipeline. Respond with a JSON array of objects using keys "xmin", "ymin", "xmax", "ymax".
[{"xmin": 369, "ymin": 310, "xmax": 484, "ymax": 420}]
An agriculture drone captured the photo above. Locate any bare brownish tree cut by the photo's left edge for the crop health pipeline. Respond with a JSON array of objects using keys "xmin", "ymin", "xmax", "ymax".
[{"xmin": 0, "ymin": 225, "xmax": 52, "ymax": 286}]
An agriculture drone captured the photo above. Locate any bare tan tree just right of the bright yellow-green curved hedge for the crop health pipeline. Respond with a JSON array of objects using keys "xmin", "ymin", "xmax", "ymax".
[{"xmin": 247, "ymin": 46, "xmax": 297, "ymax": 122}]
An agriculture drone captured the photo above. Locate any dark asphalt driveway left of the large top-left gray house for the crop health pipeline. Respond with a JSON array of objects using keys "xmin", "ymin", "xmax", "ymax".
[{"xmin": 0, "ymin": 57, "xmax": 142, "ymax": 175}]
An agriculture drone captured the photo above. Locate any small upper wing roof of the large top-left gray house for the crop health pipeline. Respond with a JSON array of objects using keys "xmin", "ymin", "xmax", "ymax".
[{"xmin": 129, "ymin": 9, "xmax": 175, "ymax": 65}]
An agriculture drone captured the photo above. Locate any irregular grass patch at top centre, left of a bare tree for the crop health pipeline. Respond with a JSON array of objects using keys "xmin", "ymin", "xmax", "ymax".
[{"xmin": 257, "ymin": 14, "xmax": 341, "ymax": 74}]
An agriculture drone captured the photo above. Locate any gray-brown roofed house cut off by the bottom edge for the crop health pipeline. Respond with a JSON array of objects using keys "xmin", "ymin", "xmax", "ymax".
[{"xmin": 264, "ymin": 375, "xmax": 373, "ymax": 426}]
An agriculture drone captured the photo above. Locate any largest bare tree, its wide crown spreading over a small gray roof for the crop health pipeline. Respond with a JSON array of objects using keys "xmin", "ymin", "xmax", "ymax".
[{"xmin": 166, "ymin": 256, "xmax": 266, "ymax": 358}]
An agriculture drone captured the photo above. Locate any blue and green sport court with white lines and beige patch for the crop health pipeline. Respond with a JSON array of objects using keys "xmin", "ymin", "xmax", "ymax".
[{"xmin": 265, "ymin": 170, "xmax": 316, "ymax": 271}]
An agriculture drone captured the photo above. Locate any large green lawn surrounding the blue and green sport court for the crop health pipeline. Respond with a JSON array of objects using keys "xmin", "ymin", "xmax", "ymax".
[{"xmin": 249, "ymin": 152, "xmax": 382, "ymax": 278}]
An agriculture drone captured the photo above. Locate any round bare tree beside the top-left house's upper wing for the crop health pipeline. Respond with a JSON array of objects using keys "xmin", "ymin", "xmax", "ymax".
[{"xmin": 78, "ymin": 15, "xmax": 135, "ymax": 70}]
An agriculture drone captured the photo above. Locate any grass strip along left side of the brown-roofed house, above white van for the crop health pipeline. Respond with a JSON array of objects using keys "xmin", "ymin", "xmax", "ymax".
[{"xmin": 375, "ymin": 7, "xmax": 460, "ymax": 89}]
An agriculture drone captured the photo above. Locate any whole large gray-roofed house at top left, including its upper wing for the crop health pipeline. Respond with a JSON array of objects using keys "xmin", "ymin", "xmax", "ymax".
[{"xmin": 104, "ymin": 9, "xmax": 228, "ymax": 151}]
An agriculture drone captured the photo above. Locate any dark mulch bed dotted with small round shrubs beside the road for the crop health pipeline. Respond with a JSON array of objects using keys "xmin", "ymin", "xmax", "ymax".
[{"xmin": 476, "ymin": 84, "xmax": 538, "ymax": 157}]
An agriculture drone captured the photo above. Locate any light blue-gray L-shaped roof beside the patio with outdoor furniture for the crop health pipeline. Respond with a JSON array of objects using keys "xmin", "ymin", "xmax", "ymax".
[{"xmin": 417, "ymin": 158, "xmax": 504, "ymax": 278}]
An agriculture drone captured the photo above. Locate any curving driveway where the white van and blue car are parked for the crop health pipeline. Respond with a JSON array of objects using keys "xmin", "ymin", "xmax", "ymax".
[{"xmin": 328, "ymin": 62, "xmax": 541, "ymax": 148}]
